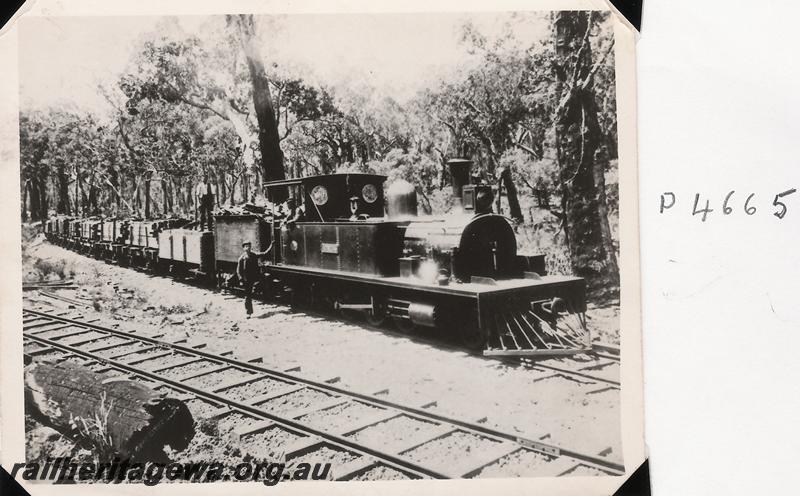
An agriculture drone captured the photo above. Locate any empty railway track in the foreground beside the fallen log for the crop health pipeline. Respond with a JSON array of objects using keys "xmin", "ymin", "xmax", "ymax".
[{"xmin": 23, "ymin": 309, "xmax": 624, "ymax": 480}]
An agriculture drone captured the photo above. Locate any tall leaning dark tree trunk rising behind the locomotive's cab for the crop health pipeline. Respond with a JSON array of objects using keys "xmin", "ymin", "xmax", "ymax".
[{"xmin": 228, "ymin": 14, "xmax": 288, "ymax": 201}]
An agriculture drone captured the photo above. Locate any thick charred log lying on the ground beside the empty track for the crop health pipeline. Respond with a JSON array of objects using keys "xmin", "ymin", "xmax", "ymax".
[{"xmin": 25, "ymin": 361, "xmax": 194, "ymax": 463}]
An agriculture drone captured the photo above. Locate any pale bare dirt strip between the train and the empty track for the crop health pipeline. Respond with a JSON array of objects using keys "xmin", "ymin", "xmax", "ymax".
[{"xmin": 17, "ymin": 237, "xmax": 622, "ymax": 474}]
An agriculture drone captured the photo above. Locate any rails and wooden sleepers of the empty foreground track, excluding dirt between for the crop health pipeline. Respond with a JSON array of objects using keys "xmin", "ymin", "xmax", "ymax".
[{"xmin": 23, "ymin": 309, "xmax": 624, "ymax": 480}]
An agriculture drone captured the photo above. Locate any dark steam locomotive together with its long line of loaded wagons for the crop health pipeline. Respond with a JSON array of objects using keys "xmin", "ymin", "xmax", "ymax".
[{"xmin": 45, "ymin": 160, "xmax": 591, "ymax": 355}]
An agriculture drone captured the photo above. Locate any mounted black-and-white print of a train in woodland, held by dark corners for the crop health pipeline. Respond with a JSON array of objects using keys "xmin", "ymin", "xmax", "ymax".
[{"xmin": 3, "ymin": 4, "xmax": 643, "ymax": 494}]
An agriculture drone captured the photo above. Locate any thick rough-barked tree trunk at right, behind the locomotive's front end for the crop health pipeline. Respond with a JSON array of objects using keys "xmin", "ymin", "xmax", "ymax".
[{"xmin": 554, "ymin": 11, "xmax": 618, "ymax": 285}]
